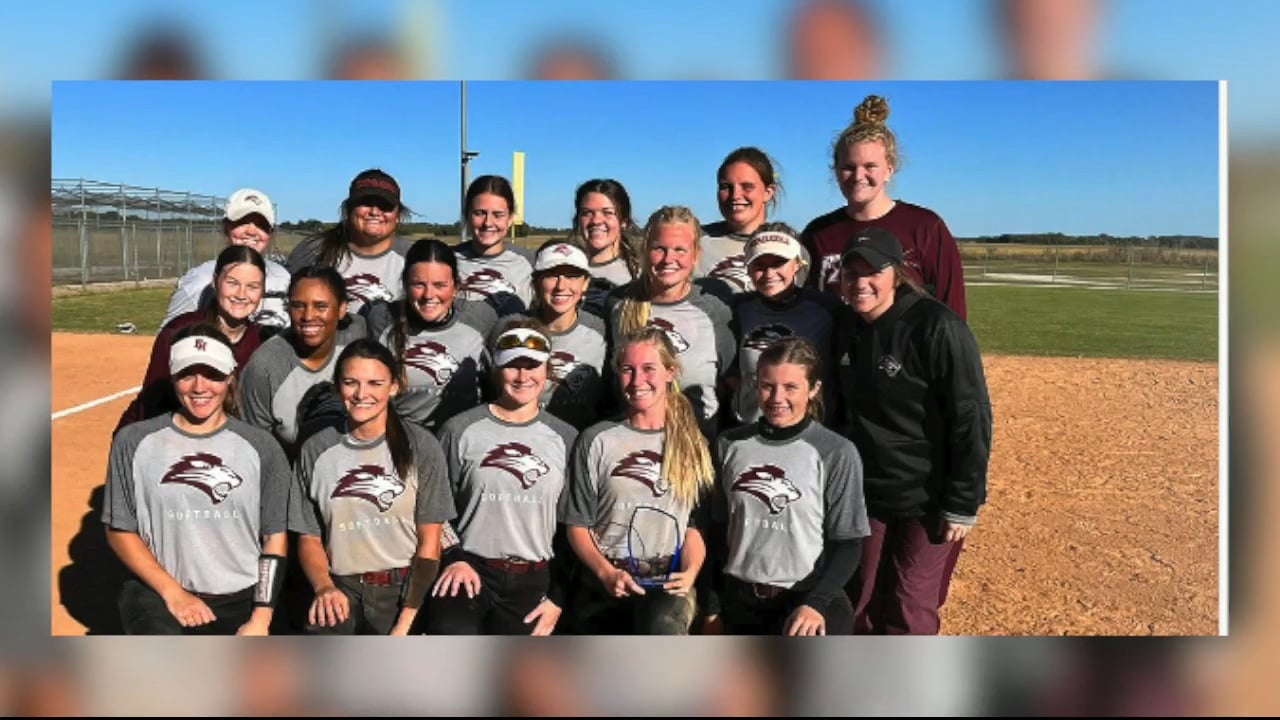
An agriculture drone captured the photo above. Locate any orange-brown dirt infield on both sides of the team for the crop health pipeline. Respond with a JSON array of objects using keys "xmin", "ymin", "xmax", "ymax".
[{"xmin": 52, "ymin": 334, "xmax": 1219, "ymax": 635}]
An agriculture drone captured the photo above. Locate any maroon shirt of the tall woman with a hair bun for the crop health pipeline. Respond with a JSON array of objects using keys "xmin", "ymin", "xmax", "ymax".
[{"xmin": 800, "ymin": 200, "xmax": 968, "ymax": 320}]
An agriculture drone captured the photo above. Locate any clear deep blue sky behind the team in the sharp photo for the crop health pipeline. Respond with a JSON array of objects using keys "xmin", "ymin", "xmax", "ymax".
[{"xmin": 52, "ymin": 81, "xmax": 1219, "ymax": 236}]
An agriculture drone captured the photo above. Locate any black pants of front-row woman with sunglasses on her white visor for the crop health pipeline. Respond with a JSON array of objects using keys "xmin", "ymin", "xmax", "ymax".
[{"xmin": 424, "ymin": 555, "xmax": 558, "ymax": 635}]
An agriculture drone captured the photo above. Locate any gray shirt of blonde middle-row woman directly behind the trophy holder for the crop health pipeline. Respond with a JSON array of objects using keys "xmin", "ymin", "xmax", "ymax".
[{"xmin": 609, "ymin": 283, "xmax": 735, "ymax": 420}]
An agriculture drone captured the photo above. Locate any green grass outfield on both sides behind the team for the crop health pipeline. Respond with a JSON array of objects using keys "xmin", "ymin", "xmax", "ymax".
[{"xmin": 52, "ymin": 280, "xmax": 1217, "ymax": 361}]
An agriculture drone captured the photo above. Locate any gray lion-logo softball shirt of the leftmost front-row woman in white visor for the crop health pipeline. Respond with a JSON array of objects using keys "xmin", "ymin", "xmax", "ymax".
[{"xmin": 102, "ymin": 415, "xmax": 289, "ymax": 594}]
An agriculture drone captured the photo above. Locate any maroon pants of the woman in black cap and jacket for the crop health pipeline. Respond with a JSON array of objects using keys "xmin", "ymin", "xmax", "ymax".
[{"xmin": 846, "ymin": 515, "xmax": 959, "ymax": 635}]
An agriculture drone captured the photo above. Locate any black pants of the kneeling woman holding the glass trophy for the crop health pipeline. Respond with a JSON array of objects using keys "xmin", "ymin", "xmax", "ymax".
[{"xmin": 570, "ymin": 573, "xmax": 698, "ymax": 635}]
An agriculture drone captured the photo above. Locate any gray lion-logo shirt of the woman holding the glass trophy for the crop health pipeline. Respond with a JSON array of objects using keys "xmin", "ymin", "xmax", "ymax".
[{"xmin": 564, "ymin": 420, "xmax": 696, "ymax": 560}]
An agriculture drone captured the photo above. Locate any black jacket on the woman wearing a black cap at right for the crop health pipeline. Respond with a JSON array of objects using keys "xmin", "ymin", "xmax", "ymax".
[{"xmin": 837, "ymin": 286, "xmax": 992, "ymax": 518}]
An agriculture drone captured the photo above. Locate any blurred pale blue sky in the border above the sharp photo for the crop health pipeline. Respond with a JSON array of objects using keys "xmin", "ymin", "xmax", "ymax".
[{"xmin": 0, "ymin": 0, "xmax": 1280, "ymax": 143}]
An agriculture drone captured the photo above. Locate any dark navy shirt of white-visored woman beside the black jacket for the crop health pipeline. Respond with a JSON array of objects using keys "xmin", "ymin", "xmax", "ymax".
[{"xmin": 731, "ymin": 287, "xmax": 840, "ymax": 423}]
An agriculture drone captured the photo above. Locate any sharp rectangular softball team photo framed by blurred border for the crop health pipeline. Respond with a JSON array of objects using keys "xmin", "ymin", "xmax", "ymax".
[{"xmin": 51, "ymin": 81, "xmax": 1226, "ymax": 632}]
